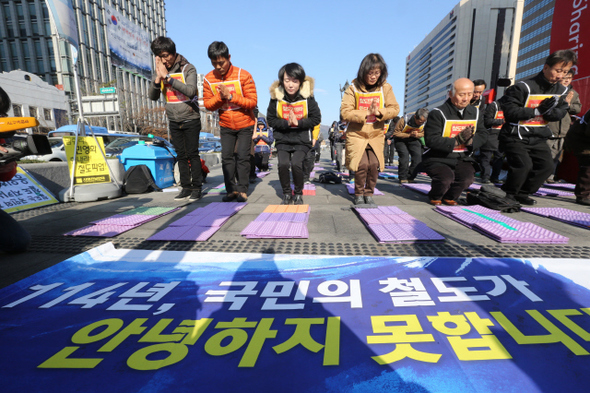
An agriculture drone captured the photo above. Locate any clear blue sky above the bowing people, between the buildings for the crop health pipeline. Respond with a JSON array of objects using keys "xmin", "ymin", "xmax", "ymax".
[{"xmin": 166, "ymin": 0, "xmax": 459, "ymax": 125}]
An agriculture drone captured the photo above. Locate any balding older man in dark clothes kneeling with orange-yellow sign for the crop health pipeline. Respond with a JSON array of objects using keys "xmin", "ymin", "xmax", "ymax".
[{"xmin": 422, "ymin": 78, "xmax": 488, "ymax": 206}]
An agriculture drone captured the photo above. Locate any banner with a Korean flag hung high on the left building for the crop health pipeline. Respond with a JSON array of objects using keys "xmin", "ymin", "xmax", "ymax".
[{"xmin": 104, "ymin": 3, "xmax": 152, "ymax": 79}]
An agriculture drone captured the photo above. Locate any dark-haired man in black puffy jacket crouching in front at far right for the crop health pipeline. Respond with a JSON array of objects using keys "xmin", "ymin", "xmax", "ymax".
[{"xmin": 499, "ymin": 50, "xmax": 578, "ymax": 205}]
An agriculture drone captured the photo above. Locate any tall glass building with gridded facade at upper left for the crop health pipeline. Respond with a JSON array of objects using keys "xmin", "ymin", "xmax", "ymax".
[{"xmin": 0, "ymin": 0, "xmax": 166, "ymax": 130}]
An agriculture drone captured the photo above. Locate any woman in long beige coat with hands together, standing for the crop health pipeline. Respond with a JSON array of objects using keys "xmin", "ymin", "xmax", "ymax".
[{"xmin": 340, "ymin": 53, "xmax": 399, "ymax": 205}]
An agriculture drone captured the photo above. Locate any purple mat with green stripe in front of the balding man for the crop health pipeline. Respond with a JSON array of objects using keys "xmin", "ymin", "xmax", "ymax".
[{"xmin": 435, "ymin": 205, "xmax": 569, "ymax": 244}]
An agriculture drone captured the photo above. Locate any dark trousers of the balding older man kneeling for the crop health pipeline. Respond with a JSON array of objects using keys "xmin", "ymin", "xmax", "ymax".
[{"xmin": 426, "ymin": 161, "xmax": 475, "ymax": 201}]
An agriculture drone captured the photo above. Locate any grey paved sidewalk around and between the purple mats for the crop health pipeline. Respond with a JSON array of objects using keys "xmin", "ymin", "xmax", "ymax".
[{"xmin": 0, "ymin": 156, "xmax": 590, "ymax": 287}]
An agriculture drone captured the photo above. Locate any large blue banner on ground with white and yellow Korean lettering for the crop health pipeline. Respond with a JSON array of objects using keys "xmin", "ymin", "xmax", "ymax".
[{"xmin": 0, "ymin": 244, "xmax": 590, "ymax": 393}]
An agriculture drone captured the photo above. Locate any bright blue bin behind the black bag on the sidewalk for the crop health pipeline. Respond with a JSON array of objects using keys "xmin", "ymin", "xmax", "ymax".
[{"xmin": 119, "ymin": 141, "xmax": 174, "ymax": 188}]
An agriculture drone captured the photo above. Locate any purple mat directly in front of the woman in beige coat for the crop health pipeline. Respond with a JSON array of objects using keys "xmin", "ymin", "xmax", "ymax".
[{"xmin": 355, "ymin": 206, "xmax": 444, "ymax": 243}]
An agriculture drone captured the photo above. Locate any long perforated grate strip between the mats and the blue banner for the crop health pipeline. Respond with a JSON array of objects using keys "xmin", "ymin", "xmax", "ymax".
[{"xmin": 29, "ymin": 236, "xmax": 590, "ymax": 259}]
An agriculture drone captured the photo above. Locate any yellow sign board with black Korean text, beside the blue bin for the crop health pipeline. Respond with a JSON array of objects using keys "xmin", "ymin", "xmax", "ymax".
[{"xmin": 63, "ymin": 136, "xmax": 111, "ymax": 185}]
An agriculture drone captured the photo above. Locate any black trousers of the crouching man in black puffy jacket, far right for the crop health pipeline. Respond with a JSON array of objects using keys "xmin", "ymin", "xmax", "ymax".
[{"xmin": 500, "ymin": 138, "xmax": 553, "ymax": 195}]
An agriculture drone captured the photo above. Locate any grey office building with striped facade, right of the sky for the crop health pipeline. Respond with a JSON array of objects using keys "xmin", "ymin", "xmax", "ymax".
[{"xmin": 404, "ymin": 0, "xmax": 524, "ymax": 113}]
